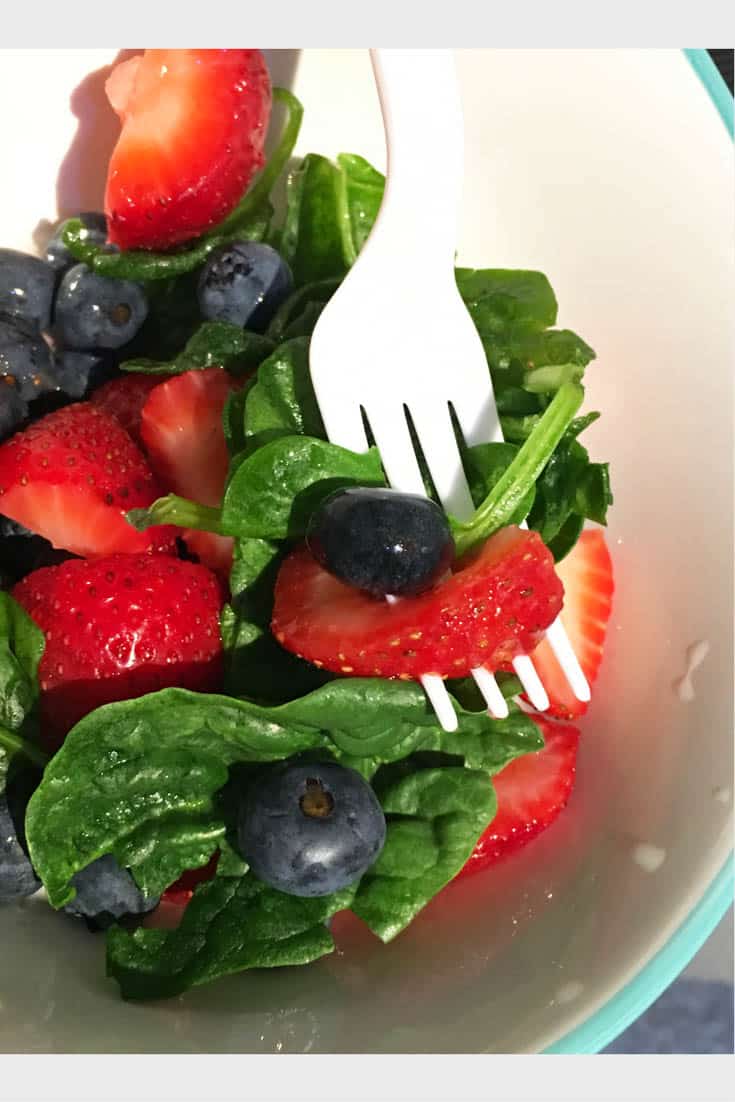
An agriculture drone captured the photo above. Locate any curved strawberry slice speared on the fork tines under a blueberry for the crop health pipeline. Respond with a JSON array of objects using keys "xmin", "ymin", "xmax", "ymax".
[{"xmin": 271, "ymin": 527, "xmax": 563, "ymax": 680}]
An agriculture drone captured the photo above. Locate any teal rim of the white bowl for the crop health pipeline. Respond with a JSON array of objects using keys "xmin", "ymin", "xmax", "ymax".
[{"xmin": 544, "ymin": 50, "xmax": 735, "ymax": 1056}]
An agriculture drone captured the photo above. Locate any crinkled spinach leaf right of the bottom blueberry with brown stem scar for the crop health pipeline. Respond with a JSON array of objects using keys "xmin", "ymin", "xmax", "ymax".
[{"xmin": 352, "ymin": 767, "xmax": 496, "ymax": 941}]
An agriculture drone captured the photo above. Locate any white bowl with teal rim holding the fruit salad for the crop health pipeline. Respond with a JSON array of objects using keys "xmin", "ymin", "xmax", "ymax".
[{"xmin": 0, "ymin": 50, "xmax": 733, "ymax": 1052}]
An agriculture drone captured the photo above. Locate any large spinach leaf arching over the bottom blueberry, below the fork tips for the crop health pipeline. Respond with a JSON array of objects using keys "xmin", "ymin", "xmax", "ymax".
[{"xmin": 26, "ymin": 679, "xmax": 541, "ymax": 907}]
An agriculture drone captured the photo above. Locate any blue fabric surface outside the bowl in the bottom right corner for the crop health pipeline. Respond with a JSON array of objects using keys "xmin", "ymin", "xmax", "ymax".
[{"xmin": 603, "ymin": 980, "xmax": 735, "ymax": 1055}]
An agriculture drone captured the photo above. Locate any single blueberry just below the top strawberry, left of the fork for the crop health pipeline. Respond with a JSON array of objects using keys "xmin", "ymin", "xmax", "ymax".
[{"xmin": 197, "ymin": 241, "xmax": 293, "ymax": 332}]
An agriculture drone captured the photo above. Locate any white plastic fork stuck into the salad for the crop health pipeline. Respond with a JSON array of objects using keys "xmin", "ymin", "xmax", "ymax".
[{"xmin": 310, "ymin": 50, "xmax": 590, "ymax": 731}]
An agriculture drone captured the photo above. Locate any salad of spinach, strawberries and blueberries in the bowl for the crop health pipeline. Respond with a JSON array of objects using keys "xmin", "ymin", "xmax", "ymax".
[{"xmin": 0, "ymin": 50, "xmax": 613, "ymax": 1000}]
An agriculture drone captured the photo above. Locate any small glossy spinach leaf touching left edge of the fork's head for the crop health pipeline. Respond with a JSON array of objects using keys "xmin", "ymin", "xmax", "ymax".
[{"xmin": 245, "ymin": 337, "xmax": 325, "ymax": 451}]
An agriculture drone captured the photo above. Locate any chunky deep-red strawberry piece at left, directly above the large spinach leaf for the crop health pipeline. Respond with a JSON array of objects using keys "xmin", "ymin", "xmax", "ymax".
[{"xmin": 12, "ymin": 553, "xmax": 223, "ymax": 746}]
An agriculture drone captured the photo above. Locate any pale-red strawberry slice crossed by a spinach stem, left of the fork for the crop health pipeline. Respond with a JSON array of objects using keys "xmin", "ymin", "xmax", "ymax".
[{"xmin": 141, "ymin": 367, "xmax": 242, "ymax": 574}]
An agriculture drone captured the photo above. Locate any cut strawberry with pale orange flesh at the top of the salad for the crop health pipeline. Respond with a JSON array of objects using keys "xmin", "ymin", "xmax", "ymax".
[{"xmin": 105, "ymin": 50, "xmax": 271, "ymax": 249}]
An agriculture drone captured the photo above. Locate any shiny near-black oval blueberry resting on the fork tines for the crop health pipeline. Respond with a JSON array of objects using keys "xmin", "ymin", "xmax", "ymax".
[{"xmin": 306, "ymin": 486, "xmax": 454, "ymax": 597}]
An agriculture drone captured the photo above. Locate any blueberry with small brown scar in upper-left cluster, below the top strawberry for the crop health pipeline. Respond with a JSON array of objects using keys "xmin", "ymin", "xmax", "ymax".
[{"xmin": 54, "ymin": 264, "xmax": 148, "ymax": 350}]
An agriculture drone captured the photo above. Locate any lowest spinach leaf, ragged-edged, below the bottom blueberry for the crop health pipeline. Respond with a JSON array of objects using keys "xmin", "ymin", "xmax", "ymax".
[{"xmin": 107, "ymin": 873, "xmax": 353, "ymax": 1000}]
